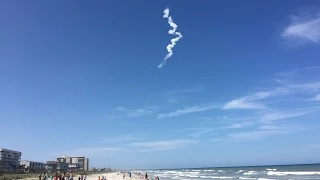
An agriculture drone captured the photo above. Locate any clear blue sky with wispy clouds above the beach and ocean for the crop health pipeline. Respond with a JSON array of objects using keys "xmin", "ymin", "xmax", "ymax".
[{"xmin": 0, "ymin": 0, "xmax": 320, "ymax": 168}]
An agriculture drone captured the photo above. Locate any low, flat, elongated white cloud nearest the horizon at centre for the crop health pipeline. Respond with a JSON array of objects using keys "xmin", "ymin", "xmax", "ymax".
[{"xmin": 130, "ymin": 139, "xmax": 198, "ymax": 151}]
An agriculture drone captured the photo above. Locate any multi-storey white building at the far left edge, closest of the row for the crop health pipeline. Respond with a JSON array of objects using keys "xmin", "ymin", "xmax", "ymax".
[{"xmin": 0, "ymin": 148, "xmax": 21, "ymax": 171}]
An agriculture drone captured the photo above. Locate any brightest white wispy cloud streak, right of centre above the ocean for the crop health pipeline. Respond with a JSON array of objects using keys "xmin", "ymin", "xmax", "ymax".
[{"xmin": 222, "ymin": 88, "xmax": 287, "ymax": 110}]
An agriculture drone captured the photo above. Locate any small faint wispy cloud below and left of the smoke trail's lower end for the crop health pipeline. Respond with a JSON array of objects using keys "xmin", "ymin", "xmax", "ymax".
[{"xmin": 116, "ymin": 106, "xmax": 159, "ymax": 117}]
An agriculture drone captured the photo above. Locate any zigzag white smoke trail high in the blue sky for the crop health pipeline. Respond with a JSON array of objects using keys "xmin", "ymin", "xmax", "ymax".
[{"xmin": 158, "ymin": 8, "xmax": 182, "ymax": 68}]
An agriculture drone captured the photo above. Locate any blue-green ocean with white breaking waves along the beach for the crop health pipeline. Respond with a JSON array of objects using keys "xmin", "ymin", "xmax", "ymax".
[{"xmin": 147, "ymin": 164, "xmax": 320, "ymax": 180}]
